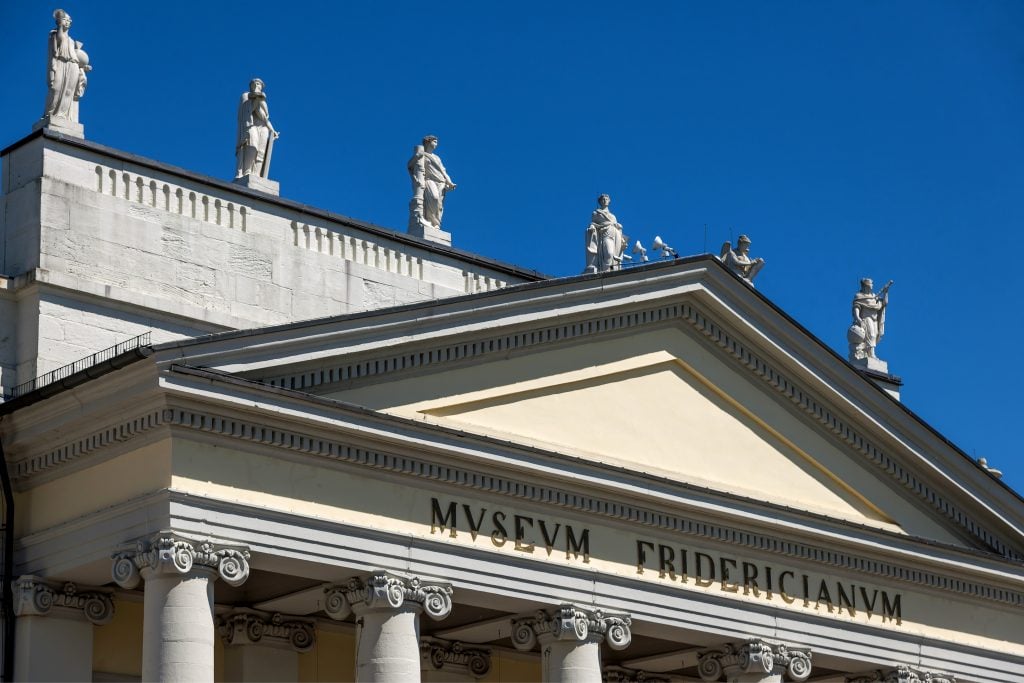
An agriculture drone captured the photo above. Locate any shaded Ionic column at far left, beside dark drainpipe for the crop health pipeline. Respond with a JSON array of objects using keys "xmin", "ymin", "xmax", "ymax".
[{"xmin": 13, "ymin": 577, "xmax": 114, "ymax": 681}]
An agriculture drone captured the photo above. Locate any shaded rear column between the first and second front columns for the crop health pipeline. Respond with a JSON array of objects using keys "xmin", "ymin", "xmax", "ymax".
[{"xmin": 217, "ymin": 609, "xmax": 316, "ymax": 683}]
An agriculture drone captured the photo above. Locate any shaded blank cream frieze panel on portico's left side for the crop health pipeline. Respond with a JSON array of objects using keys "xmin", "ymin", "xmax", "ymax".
[{"xmin": 15, "ymin": 441, "xmax": 171, "ymax": 536}]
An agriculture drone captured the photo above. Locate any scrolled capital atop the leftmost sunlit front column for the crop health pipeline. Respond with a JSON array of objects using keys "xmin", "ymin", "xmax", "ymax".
[{"xmin": 113, "ymin": 531, "xmax": 249, "ymax": 589}]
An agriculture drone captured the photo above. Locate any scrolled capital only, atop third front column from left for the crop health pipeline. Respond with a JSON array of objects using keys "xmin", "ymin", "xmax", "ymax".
[{"xmin": 512, "ymin": 605, "xmax": 633, "ymax": 650}]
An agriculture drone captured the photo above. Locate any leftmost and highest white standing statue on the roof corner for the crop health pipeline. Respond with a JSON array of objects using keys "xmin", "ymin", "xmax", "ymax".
[{"xmin": 42, "ymin": 9, "xmax": 92, "ymax": 134}]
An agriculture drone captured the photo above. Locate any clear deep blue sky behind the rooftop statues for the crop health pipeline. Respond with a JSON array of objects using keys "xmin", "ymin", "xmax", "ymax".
[{"xmin": 0, "ymin": 0, "xmax": 1024, "ymax": 497}]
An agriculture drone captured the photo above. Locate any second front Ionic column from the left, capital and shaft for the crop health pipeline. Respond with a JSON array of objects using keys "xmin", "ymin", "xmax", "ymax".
[{"xmin": 325, "ymin": 570, "xmax": 452, "ymax": 683}]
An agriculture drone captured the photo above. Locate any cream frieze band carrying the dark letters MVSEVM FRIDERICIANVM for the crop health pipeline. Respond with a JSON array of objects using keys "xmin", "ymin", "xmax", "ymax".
[{"xmin": 167, "ymin": 440, "xmax": 1024, "ymax": 655}]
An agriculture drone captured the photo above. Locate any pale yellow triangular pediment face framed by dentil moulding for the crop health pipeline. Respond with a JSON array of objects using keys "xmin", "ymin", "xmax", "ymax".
[{"xmin": 332, "ymin": 327, "xmax": 964, "ymax": 545}]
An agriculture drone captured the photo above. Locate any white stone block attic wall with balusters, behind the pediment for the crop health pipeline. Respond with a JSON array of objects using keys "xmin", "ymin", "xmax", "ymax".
[{"xmin": 0, "ymin": 134, "xmax": 537, "ymax": 391}]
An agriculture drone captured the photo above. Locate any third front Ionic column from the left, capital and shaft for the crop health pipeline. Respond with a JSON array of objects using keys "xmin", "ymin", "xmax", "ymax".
[{"xmin": 512, "ymin": 605, "xmax": 632, "ymax": 683}]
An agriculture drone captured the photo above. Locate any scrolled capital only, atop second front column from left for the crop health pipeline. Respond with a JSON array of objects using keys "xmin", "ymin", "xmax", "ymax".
[{"xmin": 324, "ymin": 570, "xmax": 452, "ymax": 621}]
